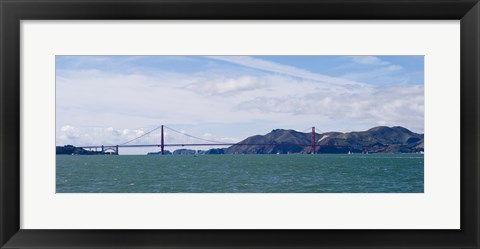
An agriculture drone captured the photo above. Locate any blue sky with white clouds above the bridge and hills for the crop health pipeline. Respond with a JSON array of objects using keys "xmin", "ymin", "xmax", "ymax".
[{"xmin": 56, "ymin": 56, "xmax": 424, "ymax": 153}]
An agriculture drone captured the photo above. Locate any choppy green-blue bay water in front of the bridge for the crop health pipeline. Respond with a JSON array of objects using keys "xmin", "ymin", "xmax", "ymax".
[{"xmin": 56, "ymin": 154, "xmax": 424, "ymax": 193}]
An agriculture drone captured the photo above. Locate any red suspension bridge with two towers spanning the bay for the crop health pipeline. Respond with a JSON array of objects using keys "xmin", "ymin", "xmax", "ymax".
[{"xmin": 78, "ymin": 125, "xmax": 319, "ymax": 155}]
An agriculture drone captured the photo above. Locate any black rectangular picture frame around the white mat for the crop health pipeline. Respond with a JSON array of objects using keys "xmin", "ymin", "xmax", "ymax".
[{"xmin": 0, "ymin": 0, "xmax": 480, "ymax": 248}]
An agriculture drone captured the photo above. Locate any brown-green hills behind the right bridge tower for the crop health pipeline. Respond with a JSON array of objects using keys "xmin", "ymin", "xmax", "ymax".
[{"xmin": 225, "ymin": 126, "xmax": 423, "ymax": 154}]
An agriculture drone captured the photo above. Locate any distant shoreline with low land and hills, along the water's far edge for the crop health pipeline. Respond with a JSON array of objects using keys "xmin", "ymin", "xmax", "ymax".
[{"xmin": 56, "ymin": 126, "xmax": 424, "ymax": 155}]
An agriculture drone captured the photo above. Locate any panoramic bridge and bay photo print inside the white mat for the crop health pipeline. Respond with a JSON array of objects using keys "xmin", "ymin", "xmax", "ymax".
[{"xmin": 54, "ymin": 54, "xmax": 426, "ymax": 195}]
